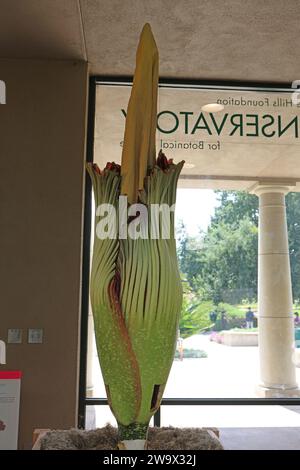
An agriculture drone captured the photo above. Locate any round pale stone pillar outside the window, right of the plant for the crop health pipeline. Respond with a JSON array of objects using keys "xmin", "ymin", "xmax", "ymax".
[{"xmin": 253, "ymin": 183, "xmax": 299, "ymax": 397}]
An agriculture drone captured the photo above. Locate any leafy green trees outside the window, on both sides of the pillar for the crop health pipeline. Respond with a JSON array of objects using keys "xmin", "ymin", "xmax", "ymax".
[{"xmin": 178, "ymin": 191, "xmax": 300, "ymax": 304}]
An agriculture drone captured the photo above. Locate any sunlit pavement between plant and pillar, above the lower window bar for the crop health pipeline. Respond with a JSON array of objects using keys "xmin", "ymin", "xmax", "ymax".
[{"xmin": 164, "ymin": 335, "xmax": 259, "ymax": 398}]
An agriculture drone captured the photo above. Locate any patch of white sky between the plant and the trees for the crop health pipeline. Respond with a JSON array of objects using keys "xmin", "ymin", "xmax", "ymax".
[{"xmin": 175, "ymin": 188, "xmax": 218, "ymax": 236}]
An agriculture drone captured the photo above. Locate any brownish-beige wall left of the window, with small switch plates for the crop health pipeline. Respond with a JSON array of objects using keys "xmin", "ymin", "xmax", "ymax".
[{"xmin": 0, "ymin": 60, "xmax": 88, "ymax": 448}]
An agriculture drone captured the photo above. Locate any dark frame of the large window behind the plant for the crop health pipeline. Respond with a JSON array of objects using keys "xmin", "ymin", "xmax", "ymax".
[{"xmin": 78, "ymin": 75, "xmax": 300, "ymax": 429}]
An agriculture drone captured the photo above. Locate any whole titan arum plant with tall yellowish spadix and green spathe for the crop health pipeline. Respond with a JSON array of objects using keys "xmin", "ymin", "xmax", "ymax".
[{"xmin": 88, "ymin": 24, "xmax": 184, "ymax": 449}]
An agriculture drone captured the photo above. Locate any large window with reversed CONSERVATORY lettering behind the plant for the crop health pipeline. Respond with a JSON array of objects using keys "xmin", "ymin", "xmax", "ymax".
[{"xmin": 80, "ymin": 79, "xmax": 300, "ymax": 427}]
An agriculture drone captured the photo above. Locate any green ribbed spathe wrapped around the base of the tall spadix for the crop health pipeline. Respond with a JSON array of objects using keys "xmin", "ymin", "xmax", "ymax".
[{"xmin": 88, "ymin": 157, "xmax": 182, "ymax": 439}]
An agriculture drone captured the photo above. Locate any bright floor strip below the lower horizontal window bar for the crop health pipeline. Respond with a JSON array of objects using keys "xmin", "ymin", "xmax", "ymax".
[{"xmin": 87, "ymin": 405, "xmax": 300, "ymax": 450}]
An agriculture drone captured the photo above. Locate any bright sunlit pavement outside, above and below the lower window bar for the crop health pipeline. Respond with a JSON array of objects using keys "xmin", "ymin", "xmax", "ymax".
[{"xmin": 88, "ymin": 335, "xmax": 300, "ymax": 436}]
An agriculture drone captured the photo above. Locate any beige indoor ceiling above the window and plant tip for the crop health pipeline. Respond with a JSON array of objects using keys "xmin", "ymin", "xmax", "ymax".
[{"xmin": 0, "ymin": 0, "xmax": 300, "ymax": 83}]
